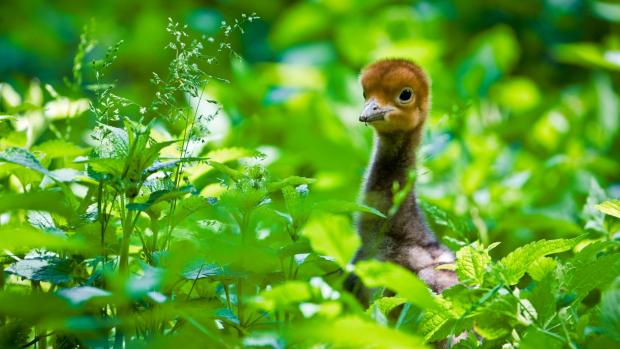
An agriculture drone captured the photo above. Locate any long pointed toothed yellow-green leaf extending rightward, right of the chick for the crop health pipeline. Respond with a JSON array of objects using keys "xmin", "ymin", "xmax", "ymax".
[{"xmin": 497, "ymin": 238, "xmax": 581, "ymax": 285}]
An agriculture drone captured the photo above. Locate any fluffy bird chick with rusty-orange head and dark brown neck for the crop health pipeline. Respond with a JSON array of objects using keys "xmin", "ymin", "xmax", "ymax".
[{"xmin": 352, "ymin": 59, "xmax": 458, "ymax": 302}]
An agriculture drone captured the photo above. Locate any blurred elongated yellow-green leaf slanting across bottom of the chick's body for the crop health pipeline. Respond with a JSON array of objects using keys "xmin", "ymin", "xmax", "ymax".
[{"xmin": 355, "ymin": 260, "xmax": 437, "ymax": 309}]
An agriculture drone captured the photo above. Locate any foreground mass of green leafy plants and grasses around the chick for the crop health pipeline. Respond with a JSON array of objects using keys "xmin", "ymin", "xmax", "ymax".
[{"xmin": 0, "ymin": 15, "xmax": 620, "ymax": 348}]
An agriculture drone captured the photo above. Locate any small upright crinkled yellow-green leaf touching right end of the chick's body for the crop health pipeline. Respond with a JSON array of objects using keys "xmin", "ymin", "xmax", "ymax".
[{"xmin": 455, "ymin": 243, "xmax": 491, "ymax": 286}]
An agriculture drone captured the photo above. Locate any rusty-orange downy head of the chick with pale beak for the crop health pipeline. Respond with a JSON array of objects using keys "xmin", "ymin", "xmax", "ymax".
[{"xmin": 360, "ymin": 59, "xmax": 430, "ymax": 133}]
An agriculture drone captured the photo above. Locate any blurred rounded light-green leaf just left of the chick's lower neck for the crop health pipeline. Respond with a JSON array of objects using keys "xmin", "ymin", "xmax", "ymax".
[{"xmin": 302, "ymin": 213, "xmax": 360, "ymax": 268}]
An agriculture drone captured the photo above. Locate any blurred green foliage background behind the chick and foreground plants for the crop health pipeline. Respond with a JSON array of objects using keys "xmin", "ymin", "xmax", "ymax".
[{"xmin": 0, "ymin": 0, "xmax": 620, "ymax": 346}]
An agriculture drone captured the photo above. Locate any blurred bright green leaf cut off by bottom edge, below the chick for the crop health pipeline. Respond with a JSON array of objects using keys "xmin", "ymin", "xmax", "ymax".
[{"xmin": 286, "ymin": 315, "xmax": 428, "ymax": 349}]
